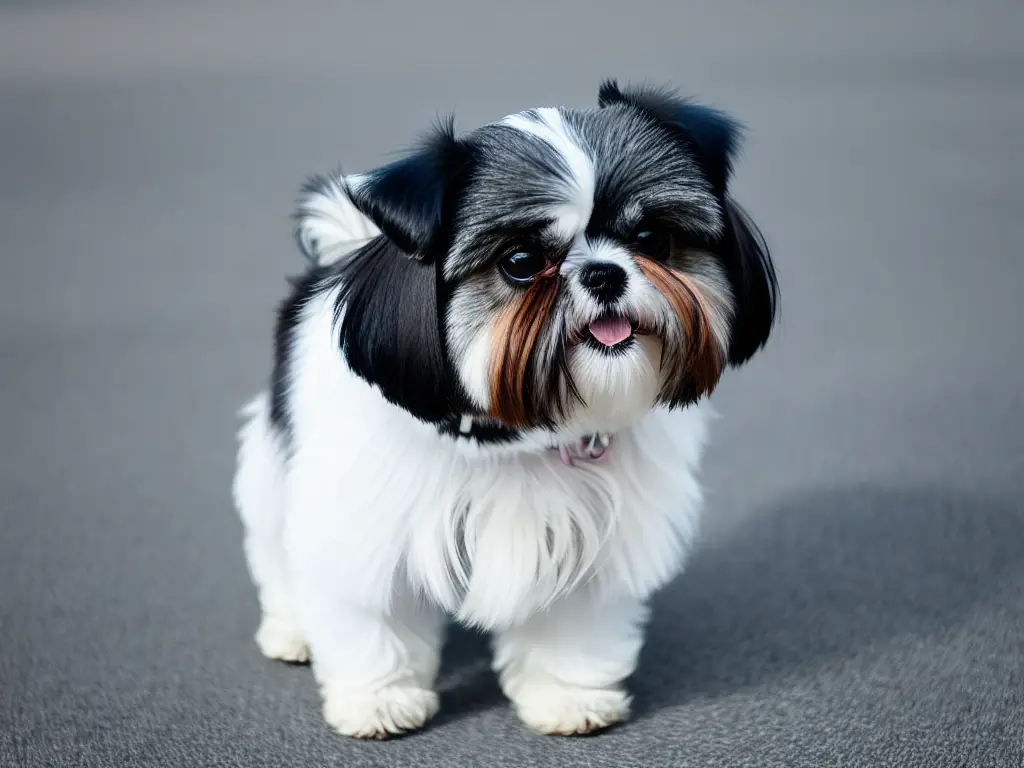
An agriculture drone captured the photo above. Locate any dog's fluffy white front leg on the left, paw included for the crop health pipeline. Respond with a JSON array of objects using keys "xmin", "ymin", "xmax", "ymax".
[{"xmin": 286, "ymin": 462, "xmax": 443, "ymax": 738}]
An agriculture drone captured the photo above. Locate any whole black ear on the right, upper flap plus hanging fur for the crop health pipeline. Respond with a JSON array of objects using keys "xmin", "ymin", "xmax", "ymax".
[{"xmin": 598, "ymin": 80, "xmax": 778, "ymax": 366}]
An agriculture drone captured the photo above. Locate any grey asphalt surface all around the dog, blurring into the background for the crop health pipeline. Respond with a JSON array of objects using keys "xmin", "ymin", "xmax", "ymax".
[{"xmin": 0, "ymin": 0, "xmax": 1024, "ymax": 768}]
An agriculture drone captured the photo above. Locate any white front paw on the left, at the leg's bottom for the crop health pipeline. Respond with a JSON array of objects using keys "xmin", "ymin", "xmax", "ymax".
[{"xmin": 324, "ymin": 685, "xmax": 437, "ymax": 738}]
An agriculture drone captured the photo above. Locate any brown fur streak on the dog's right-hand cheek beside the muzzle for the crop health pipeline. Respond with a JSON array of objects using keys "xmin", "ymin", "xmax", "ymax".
[{"xmin": 635, "ymin": 256, "xmax": 724, "ymax": 402}]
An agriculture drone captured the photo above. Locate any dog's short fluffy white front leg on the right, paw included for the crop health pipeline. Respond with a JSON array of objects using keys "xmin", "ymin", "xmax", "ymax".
[{"xmin": 495, "ymin": 589, "xmax": 647, "ymax": 735}]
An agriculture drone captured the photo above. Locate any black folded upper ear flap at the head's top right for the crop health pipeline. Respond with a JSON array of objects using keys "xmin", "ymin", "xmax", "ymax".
[{"xmin": 597, "ymin": 80, "xmax": 742, "ymax": 195}]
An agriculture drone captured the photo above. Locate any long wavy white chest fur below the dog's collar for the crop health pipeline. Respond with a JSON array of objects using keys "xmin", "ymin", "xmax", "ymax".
[{"xmin": 408, "ymin": 428, "xmax": 697, "ymax": 628}]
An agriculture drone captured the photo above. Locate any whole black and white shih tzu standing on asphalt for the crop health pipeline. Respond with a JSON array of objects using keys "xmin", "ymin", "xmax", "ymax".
[{"xmin": 233, "ymin": 82, "xmax": 777, "ymax": 738}]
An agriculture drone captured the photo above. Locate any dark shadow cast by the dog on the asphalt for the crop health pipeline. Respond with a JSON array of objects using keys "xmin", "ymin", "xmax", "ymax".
[{"xmin": 428, "ymin": 487, "xmax": 1024, "ymax": 719}]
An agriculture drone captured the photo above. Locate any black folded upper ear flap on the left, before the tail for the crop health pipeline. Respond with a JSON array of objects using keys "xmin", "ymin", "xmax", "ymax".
[{"xmin": 346, "ymin": 119, "xmax": 469, "ymax": 261}]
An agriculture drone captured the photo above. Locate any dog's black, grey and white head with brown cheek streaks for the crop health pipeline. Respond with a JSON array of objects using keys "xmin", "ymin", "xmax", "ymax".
[{"xmin": 298, "ymin": 82, "xmax": 777, "ymax": 442}]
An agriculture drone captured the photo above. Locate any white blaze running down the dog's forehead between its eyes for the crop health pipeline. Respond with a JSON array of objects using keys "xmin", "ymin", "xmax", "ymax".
[{"xmin": 501, "ymin": 106, "xmax": 596, "ymax": 240}]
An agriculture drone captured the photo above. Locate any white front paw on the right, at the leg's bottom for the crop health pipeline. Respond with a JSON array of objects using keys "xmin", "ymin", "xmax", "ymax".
[{"xmin": 513, "ymin": 681, "xmax": 632, "ymax": 736}]
